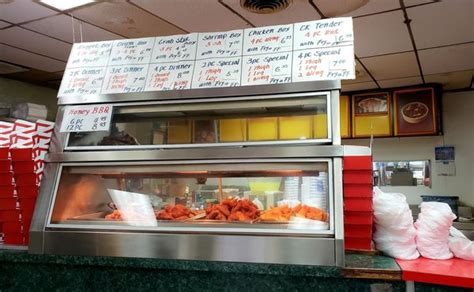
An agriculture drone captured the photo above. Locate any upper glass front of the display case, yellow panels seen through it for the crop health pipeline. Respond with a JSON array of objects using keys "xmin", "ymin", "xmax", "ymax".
[{"xmin": 68, "ymin": 95, "xmax": 328, "ymax": 146}]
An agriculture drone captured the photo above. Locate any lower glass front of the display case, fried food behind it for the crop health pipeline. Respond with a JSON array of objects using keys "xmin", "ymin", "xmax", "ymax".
[{"xmin": 51, "ymin": 162, "xmax": 330, "ymax": 232}]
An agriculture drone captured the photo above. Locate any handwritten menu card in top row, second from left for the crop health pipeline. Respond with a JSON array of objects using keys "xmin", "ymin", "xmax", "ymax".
[{"xmin": 108, "ymin": 38, "xmax": 155, "ymax": 66}]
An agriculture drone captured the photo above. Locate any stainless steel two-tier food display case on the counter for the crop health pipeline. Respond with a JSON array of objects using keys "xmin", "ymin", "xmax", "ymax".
[{"xmin": 29, "ymin": 81, "xmax": 344, "ymax": 266}]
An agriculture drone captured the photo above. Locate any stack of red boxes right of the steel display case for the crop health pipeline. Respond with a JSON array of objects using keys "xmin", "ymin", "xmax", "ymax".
[{"xmin": 343, "ymin": 156, "xmax": 373, "ymax": 250}]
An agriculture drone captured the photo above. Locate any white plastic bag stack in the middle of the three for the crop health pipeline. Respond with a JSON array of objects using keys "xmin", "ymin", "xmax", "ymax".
[{"xmin": 415, "ymin": 202, "xmax": 456, "ymax": 260}]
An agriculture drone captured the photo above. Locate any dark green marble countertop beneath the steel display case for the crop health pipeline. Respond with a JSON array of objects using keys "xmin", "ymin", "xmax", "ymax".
[{"xmin": 0, "ymin": 249, "xmax": 401, "ymax": 280}]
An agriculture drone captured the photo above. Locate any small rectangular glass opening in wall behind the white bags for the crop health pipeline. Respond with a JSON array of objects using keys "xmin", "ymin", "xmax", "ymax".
[{"xmin": 373, "ymin": 160, "xmax": 431, "ymax": 186}]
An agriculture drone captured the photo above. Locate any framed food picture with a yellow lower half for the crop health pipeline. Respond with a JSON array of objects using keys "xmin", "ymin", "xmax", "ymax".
[{"xmin": 352, "ymin": 92, "xmax": 392, "ymax": 138}]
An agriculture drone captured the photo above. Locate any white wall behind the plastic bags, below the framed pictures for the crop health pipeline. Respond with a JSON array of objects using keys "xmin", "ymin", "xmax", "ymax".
[{"xmin": 344, "ymin": 91, "xmax": 474, "ymax": 206}]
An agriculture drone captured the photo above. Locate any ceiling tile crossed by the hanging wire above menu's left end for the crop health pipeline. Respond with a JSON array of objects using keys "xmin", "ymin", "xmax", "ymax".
[{"xmin": 23, "ymin": 15, "xmax": 122, "ymax": 43}]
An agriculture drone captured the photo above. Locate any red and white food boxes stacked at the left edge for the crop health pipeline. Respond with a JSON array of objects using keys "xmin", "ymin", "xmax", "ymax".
[{"xmin": 0, "ymin": 120, "xmax": 54, "ymax": 244}]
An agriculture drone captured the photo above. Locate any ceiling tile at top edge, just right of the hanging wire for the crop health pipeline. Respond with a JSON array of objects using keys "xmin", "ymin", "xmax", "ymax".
[{"xmin": 74, "ymin": 1, "xmax": 184, "ymax": 38}]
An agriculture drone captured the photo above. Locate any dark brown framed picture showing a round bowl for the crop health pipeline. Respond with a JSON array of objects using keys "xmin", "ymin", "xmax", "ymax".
[{"xmin": 393, "ymin": 88, "xmax": 438, "ymax": 136}]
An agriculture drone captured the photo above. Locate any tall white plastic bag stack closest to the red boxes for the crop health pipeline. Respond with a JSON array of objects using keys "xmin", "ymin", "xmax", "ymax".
[{"xmin": 373, "ymin": 187, "xmax": 420, "ymax": 260}]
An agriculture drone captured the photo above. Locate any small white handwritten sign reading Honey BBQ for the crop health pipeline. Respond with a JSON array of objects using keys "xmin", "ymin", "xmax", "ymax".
[{"xmin": 60, "ymin": 104, "xmax": 112, "ymax": 132}]
